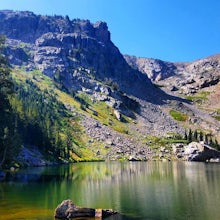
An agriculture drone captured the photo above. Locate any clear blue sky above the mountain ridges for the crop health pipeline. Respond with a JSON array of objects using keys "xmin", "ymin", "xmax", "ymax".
[{"xmin": 0, "ymin": 0, "xmax": 220, "ymax": 61}]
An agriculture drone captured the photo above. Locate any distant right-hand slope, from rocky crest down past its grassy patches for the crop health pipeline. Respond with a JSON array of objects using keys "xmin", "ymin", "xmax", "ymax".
[{"xmin": 124, "ymin": 54, "xmax": 220, "ymax": 140}]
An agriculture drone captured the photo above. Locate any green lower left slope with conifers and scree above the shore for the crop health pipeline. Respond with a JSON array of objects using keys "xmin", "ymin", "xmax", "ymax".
[{"xmin": 11, "ymin": 69, "xmax": 151, "ymax": 161}]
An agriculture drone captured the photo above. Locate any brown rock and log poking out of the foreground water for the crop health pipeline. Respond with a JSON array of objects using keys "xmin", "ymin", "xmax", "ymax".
[{"xmin": 54, "ymin": 199, "xmax": 117, "ymax": 219}]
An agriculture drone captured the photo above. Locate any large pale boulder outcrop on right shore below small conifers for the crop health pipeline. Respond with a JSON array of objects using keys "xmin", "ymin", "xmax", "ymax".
[{"xmin": 173, "ymin": 142, "xmax": 220, "ymax": 162}]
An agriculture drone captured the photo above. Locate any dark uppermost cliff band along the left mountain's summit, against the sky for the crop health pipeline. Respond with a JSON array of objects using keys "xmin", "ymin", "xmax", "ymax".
[{"xmin": 0, "ymin": 10, "xmax": 110, "ymax": 43}]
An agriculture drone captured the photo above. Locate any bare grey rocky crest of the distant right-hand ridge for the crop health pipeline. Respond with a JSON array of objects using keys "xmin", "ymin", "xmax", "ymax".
[{"xmin": 124, "ymin": 55, "xmax": 220, "ymax": 94}]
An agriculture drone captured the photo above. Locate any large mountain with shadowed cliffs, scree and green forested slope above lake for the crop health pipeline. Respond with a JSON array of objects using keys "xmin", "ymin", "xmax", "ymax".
[{"xmin": 0, "ymin": 10, "xmax": 219, "ymax": 167}]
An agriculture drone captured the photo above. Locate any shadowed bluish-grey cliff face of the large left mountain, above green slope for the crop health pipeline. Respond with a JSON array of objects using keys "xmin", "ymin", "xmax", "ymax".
[{"xmin": 0, "ymin": 11, "xmax": 151, "ymax": 99}]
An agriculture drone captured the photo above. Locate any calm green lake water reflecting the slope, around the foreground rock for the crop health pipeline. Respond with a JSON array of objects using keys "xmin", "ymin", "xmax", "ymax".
[{"xmin": 0, "ymin": 162, "xmax": 220, "ymax": 220}]
